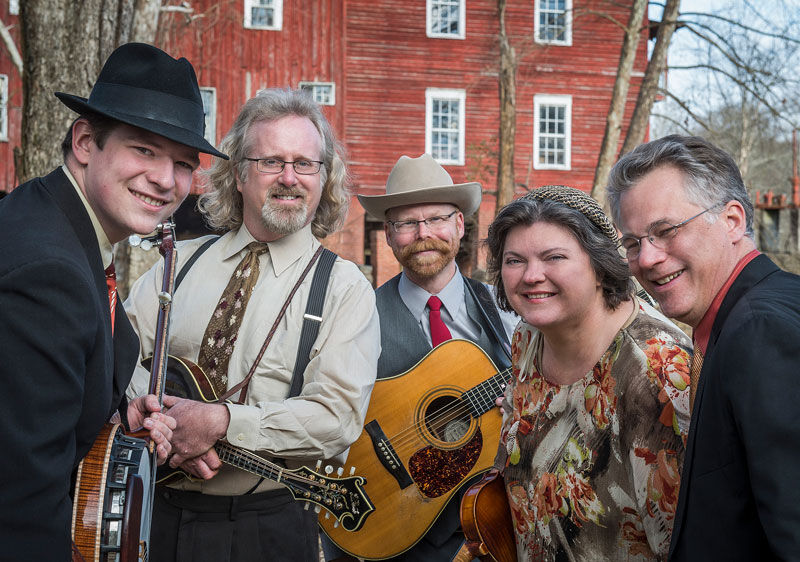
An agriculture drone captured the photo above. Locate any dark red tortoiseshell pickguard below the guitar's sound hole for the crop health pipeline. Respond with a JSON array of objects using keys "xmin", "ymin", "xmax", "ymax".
[{"xmin": 408, "ymin": 430, "xmax": 483, "ymax": 498}]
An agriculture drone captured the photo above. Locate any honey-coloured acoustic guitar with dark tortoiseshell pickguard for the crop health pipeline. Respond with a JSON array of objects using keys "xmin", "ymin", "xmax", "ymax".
[{"xmin": 319, "ymin": 339, "xmax": 510, "ymax": 560}]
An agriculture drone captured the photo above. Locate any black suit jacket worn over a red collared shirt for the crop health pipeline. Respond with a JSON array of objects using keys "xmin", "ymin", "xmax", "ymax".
[{"xmin": 670, "ymin": 255, "xmax": 800, "ymax": 561}]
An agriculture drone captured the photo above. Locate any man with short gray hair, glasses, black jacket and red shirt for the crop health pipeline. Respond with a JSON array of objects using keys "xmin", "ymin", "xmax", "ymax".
[{"xmin": 608, "ymin": 135, "xmax": 800, "ymax": 561}]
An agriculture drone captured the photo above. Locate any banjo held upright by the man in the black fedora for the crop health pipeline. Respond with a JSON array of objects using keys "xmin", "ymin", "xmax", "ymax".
[{"xmin": 72, "ymin": 222, "xmax": 177, "ymax": 562}]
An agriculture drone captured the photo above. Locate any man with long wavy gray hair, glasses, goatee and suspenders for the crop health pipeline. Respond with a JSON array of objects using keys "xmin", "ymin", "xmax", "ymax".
[{"xmin": 125, "ymin": 89, "xmax": 380, "ymax": 562}]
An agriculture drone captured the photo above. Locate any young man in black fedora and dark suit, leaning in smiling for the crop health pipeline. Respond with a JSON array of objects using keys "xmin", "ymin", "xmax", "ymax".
[{"xmin": 0, "ymin": 43, "xmax": 225, "ymax": 560}]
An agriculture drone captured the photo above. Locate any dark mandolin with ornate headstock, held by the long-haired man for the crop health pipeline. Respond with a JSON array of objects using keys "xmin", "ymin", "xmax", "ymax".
[{"xmin": 142, "ymin": 355, "xmax": 375, "ymax": 531}]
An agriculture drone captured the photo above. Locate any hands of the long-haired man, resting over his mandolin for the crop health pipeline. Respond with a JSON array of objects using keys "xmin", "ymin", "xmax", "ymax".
[{"xmin": 159, "ymin": 395, "xmax": 230, "ymax": 468}]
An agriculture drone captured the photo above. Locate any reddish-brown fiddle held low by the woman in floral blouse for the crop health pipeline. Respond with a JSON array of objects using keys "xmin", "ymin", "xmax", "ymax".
[{"xmin": 461, "ymin": 468, "xmax": 517, "ymax": 562}]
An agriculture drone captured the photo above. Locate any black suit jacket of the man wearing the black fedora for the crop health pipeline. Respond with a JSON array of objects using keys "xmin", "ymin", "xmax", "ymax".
[{"xmin": 0, "ymin": 168, "xmax": 138, "ymax": 561}]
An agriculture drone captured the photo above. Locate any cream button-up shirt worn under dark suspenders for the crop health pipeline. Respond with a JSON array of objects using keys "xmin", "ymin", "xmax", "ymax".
[{"xmin": 125, "ymin": 221, "xmax": 380, "ymax": 495}]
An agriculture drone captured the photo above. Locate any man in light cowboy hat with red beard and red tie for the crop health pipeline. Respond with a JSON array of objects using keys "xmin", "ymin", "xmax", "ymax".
[{"xmin": 326, "ymin": 154, "xmax": 517, "ymax": 561}]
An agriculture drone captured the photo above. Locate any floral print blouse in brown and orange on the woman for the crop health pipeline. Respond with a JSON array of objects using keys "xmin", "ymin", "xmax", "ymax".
[{"xmin": 500, "ymin": 302, "xmax": 691, "ymax": 561}]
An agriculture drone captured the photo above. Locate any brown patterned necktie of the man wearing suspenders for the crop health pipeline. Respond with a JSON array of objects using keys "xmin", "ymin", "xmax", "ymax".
[{"xmin": 197, "ymin": 242, "xmax": 268, "ymax": 395}]
